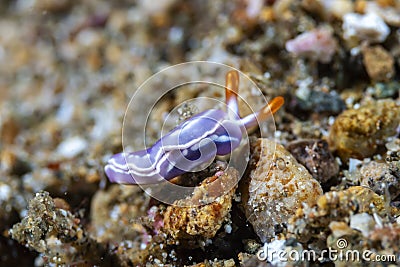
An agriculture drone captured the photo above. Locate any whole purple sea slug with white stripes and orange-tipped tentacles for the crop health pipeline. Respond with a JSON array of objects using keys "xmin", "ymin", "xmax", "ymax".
[{"xmin": 105, "ymin": 71, "xmax": 283, "ymax": 184}]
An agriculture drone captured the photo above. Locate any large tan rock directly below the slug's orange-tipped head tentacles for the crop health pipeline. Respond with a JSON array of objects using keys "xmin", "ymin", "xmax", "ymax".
[{"xmin": 242, "ymin": 139, "xmax": 322, "ymax": 242}]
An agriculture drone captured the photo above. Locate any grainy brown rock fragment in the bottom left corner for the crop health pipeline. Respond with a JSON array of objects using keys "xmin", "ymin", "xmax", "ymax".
[{"xmin": 10, "ymin": 191, "xmax": 109, "ymax": 265}]
